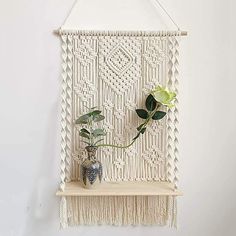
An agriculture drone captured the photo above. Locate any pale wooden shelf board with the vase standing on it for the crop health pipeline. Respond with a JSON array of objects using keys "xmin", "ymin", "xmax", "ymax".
[{"xmin": 56, "ymin": 182, "xmax": 182, "ymax": 196}]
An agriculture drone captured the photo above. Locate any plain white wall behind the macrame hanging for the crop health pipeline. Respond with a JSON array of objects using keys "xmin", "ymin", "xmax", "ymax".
[{"xmin": 0, "ymin": 0, "xmax": 236, "ymax": 236}]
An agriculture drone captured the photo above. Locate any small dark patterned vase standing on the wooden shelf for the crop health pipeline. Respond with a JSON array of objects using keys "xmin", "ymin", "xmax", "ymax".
[{"xmin": 81, "ymin": 146, "xmax": 102, "ymax": 188}]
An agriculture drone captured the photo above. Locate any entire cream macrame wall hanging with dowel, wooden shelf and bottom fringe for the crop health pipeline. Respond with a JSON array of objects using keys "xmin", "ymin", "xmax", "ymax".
[{"xmin": 54, "ymin": 2, "xmax": 186, "ymax": 228}]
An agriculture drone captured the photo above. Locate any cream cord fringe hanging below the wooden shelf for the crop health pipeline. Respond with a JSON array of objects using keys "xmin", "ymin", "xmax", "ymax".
[{"xmin": 60, "ymin": 196, "xmax": 177, "ymax": 228}]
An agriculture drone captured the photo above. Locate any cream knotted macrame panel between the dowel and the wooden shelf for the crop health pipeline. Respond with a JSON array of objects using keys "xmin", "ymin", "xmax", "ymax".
[{"xmin": 61, "ymin": 32, "xmax": 178, "ymax": 182}]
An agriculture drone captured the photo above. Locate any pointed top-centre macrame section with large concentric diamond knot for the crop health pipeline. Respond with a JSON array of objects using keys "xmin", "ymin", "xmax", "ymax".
[{"xmin": 98, "ymin": 37, "xmax": 141, "ymax": 96}]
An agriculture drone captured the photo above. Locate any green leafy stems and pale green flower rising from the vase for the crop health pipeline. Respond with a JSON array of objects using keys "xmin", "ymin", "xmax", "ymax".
[{"xmin": 76, "ymin": 85, "xmax": 176, "ymax": 148}]
